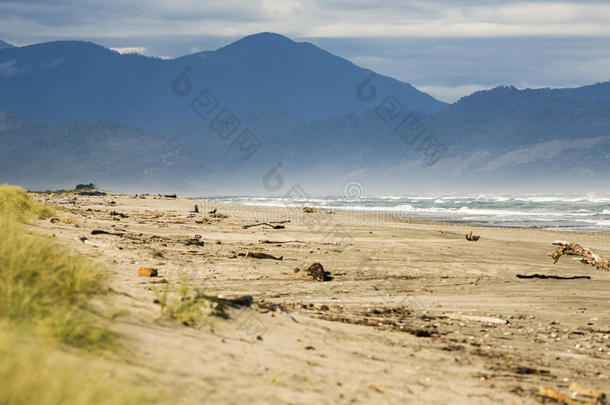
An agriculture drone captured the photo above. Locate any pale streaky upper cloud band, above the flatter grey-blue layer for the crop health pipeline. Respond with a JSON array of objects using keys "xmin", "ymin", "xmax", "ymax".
[{"xmin": 0, "ymin": 0, "xmax": 610, "ymax": 37}]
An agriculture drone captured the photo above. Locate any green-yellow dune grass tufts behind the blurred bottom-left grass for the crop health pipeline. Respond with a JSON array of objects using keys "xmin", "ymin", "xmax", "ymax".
[{"xmin": 0, "ymin": 186, "xmax": 115, "ymax": 350}]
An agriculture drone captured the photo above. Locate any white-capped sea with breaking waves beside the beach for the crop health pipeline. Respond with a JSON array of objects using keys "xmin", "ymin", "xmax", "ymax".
[{"xmin": 204, "ymin": 194, "xmax": 610, "ymax": 232}]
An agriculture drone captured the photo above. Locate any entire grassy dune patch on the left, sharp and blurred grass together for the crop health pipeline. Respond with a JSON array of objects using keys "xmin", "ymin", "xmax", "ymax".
[{"xmin": 0, "ymin": 185, "xmax": 149, "ymax": 405}]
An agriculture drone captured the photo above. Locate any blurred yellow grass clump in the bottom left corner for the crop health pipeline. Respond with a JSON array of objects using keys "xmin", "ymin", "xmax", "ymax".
[{"xmin": 0, "ymin": 324, "xmax": 148, "ymax": 405}]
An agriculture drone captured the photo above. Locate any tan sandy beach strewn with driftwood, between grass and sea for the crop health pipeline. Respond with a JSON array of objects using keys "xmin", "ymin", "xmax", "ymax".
[{"xmin": 33, "ymin": 196, "xmax": 610, "ymax": 404}]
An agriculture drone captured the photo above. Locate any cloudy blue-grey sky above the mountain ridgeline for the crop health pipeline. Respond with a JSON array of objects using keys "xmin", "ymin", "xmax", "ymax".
[{"xmin": 0, "ymin": 0, "xmax": 610, "ymax": 102}]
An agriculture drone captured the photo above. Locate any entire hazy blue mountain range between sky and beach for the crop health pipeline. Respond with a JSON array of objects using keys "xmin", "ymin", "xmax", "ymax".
[{"xmin": 0, "ymin": 33, "xmax": 610, "ymax": 194}]
